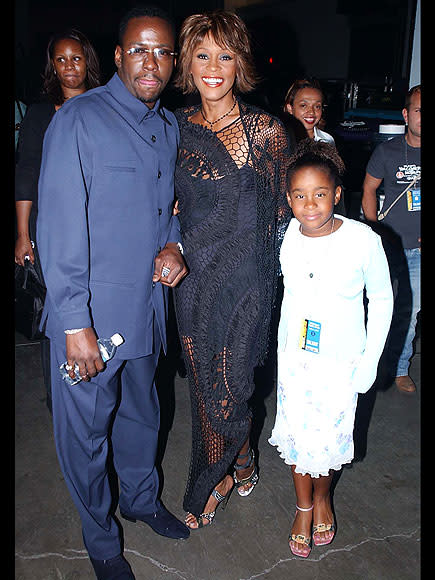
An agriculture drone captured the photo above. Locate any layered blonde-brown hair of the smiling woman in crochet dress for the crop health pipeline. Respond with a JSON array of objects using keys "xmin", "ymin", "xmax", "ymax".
[{"xmin": 174, "ymin": 10, "xmax": 258, "ymax": 94}]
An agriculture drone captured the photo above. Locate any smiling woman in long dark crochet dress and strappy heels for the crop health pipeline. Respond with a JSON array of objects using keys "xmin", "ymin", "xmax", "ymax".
[{"xmin": 175, "ymin": 11, "xmax": 289, "ymax": 529}]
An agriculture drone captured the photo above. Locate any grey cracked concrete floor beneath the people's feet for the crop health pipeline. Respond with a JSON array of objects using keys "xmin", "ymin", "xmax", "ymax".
[{"xmin": 15, "ymin": 334, "xmax": 421, "ymax": 580}]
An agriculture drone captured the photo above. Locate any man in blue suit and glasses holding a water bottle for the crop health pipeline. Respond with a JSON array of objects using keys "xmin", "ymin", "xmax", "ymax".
[{"xmin": 37, "ymin": 8, "xmax": 189, "ymax": 580}]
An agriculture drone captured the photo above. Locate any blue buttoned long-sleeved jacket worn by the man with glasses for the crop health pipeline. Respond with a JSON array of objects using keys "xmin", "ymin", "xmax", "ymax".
[{"xmin": 37, "ymin": 74, "xmax": 181, "ymax": 358}]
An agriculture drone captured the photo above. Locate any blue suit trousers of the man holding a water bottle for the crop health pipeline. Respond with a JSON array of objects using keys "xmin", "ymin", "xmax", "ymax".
[{"xmin": 50, "ymin": 332, "xmax": 161, "ymax": 560}]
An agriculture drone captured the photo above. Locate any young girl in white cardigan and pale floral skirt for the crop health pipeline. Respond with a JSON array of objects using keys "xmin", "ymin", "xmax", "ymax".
[{"xmin": 269, "ymin": 139, "xmax": 393, "ymax": 558}]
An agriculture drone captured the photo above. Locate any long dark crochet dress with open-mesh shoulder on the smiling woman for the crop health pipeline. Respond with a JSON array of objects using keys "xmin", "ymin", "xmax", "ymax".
[{"xmin": 175, "ymin": 100, "xmax": 289, "ymax": 516}]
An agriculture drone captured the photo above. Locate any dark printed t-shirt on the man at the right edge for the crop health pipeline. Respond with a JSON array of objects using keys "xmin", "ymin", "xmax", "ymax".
[{"xmin": 367, "ymin": 135, "xmax": 421, "ymax": 248}]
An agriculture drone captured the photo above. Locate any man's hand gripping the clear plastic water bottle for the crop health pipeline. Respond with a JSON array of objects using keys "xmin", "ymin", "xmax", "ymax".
[{"xmin": 66, "ymin": 327, "xmax": 104, "ymax": 381}]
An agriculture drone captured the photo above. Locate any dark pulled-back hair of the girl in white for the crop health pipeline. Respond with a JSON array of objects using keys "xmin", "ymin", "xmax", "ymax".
[{"xmin": 287, "ymin": 139, "xmax": 345, "ymax": 187}]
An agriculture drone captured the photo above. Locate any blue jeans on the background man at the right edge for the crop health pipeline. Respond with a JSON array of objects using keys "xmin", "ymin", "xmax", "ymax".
[{"xmin": 388, "ymin": 248, "xmax": 421, "ymax": 377}]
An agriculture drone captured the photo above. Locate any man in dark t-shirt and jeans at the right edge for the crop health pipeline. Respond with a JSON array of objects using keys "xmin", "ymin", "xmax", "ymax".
[{"xmin": 362, "ymin": 85, "xmax": 421, "ymax": 393}]
